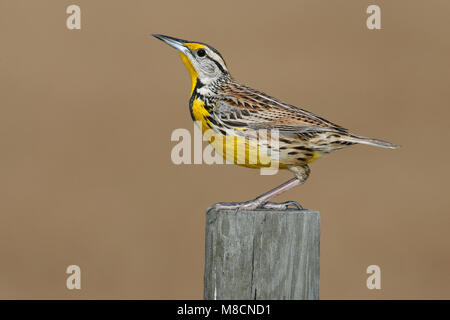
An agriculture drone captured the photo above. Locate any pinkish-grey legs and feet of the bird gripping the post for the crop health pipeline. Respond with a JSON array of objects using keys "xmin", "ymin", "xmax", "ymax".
[{"xmin": 214, "ymin": 165, "xmax": 310, "ymax": 210}]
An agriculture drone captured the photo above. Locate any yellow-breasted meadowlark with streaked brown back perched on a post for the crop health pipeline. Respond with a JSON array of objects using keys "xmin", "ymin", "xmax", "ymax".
[{"xmin": 154, "ymin": 34, "xmax": 398, "ymax": 210}]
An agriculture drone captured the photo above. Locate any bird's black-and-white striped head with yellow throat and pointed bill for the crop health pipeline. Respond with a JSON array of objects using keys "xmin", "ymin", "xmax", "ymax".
[{"xmin": 153, "ymin": 34, "xmax": 228, "ymax": 93}]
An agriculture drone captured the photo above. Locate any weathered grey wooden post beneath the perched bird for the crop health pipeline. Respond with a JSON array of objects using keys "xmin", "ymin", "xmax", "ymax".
[{"xmin": 204, "ymin": 208, "xmax": 320, "ymax": 300}]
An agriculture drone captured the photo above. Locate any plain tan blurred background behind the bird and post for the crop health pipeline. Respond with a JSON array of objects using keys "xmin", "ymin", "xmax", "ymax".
[{"xmin": 0, "ymin": 0, "xmax": 450, "ymax": 299}]
